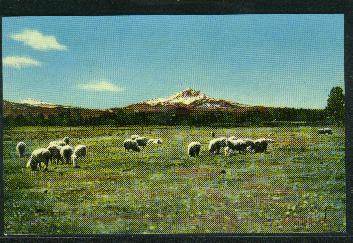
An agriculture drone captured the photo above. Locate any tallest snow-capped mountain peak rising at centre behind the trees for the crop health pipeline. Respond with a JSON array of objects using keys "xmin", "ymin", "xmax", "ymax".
[{"xmin": 128, "ymin": 89, "xmax": 248, "ymax": 110}]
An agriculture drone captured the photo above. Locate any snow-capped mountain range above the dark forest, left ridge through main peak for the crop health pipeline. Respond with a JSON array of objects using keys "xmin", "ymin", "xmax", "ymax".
[{"xmin": 4, "ymin": 89, "xmax": 250, "ymax": 114}]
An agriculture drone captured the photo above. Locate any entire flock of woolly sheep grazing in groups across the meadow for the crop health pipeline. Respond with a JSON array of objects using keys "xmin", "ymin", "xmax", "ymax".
[{"xmin": 16, "ymin": 128, "xmax": 332, "ymax": 171}]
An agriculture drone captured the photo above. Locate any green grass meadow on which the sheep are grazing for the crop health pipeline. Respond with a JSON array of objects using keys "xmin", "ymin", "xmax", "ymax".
[{"xmin": 3, "ymin": 127, "xmax": 346, "ymax": 234}]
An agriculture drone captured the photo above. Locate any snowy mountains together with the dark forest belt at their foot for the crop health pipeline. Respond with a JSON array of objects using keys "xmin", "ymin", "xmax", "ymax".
[{"xmin": 3, "ymin": 89, "xmax": 326, "ymax": 126}]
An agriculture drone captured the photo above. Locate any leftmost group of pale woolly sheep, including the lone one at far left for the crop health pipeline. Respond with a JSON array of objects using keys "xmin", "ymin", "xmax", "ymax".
[{"xmin": 16, "ymin": 137, "xmax": 87, "ymax": 171}]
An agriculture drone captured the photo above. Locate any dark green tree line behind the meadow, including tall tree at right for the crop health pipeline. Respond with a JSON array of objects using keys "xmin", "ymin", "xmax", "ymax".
[{"xmin": 4, "ymin": 87, "xmax": 344, "ymax": 127}]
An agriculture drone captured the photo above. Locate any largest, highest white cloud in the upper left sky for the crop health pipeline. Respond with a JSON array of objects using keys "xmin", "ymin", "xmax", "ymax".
[{"xmin": 10, "ymin": 29, "xmax": 67, "ymax": 51}]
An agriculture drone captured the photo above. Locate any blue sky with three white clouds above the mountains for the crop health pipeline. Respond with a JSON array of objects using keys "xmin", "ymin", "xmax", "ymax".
[{"xmin": 2, "ymin": 14, "xmax": 344, "ymax": 108}]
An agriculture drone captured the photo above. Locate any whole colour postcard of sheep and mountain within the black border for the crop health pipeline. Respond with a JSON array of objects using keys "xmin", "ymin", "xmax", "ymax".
[{"xmin": 2, "ymin": 14, "xmax": 346, "ymax": 235}]
